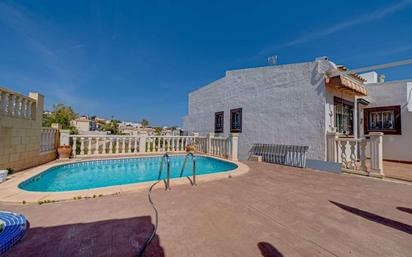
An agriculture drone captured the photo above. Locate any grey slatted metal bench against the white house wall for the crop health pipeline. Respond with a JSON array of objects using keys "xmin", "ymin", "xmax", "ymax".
[{"xmin": 249, "ymin": 144, "xmax": 309, "ymax": 168}]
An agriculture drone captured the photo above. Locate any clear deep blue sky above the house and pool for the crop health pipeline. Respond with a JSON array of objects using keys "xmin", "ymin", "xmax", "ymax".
[{"xmin": 0, "ymin": 0, "xmax": 412, "ymax": 125}]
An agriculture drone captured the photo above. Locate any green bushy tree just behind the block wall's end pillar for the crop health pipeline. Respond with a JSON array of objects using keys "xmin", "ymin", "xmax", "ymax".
[{"xmin": 42, "ymin": 104, "xmax": 77, "ymax": 129}]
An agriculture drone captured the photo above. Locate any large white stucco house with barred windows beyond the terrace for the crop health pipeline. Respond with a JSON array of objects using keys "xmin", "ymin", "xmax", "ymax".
[{"xmin": 183, "ymin": 58, "xmax": 412, "ymax": 166}]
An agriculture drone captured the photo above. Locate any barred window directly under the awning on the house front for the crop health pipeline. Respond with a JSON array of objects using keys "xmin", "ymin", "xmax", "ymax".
[{"xmin": 334, "ymin": 96, "xmax": 353, "ymax": 135}]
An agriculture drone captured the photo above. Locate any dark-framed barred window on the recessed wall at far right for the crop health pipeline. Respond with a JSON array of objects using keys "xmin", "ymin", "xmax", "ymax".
[{"xmin": 364, "ymin": 105, "xmax": 402, "ymax": 135}]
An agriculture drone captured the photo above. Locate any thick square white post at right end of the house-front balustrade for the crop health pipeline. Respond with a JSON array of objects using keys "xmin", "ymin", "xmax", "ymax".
[{"xmin": 369, "ymin": 132, "xmax": 384, "ymax": 177}]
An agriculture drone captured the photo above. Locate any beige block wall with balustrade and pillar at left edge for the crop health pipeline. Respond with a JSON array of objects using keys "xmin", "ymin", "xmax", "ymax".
[{"xmin": 0, "ymin": 89, "xmax": 56, "ymax": 171}]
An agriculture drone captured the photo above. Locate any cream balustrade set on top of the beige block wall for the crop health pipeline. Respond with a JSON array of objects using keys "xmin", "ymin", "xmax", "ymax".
[{"xmin": 0, "ymin": 88, "xmax": 36, "ymax": 119}]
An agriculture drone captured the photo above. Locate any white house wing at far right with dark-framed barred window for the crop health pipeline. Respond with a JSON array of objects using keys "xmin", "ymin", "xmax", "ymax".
[{"xmin": 361, "ymin": 72, "xmax": 412, "ymax": 162}]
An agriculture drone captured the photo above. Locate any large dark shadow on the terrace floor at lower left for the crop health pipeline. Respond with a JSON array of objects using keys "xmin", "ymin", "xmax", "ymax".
[{"xmin": 5, "ymin": 216, "xmax": 165, "ymax": 257}]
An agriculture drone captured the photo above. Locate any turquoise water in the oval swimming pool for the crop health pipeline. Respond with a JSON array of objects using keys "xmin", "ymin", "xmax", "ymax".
[{"xmin": 19, "ymin": 155, "xmax": 237, "ymax": 192}]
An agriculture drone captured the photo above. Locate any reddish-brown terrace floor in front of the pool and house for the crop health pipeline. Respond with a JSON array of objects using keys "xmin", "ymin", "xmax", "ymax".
[{"xmin": 0, "ymin": 162, "xmax": 412, "ymax": 257}]
